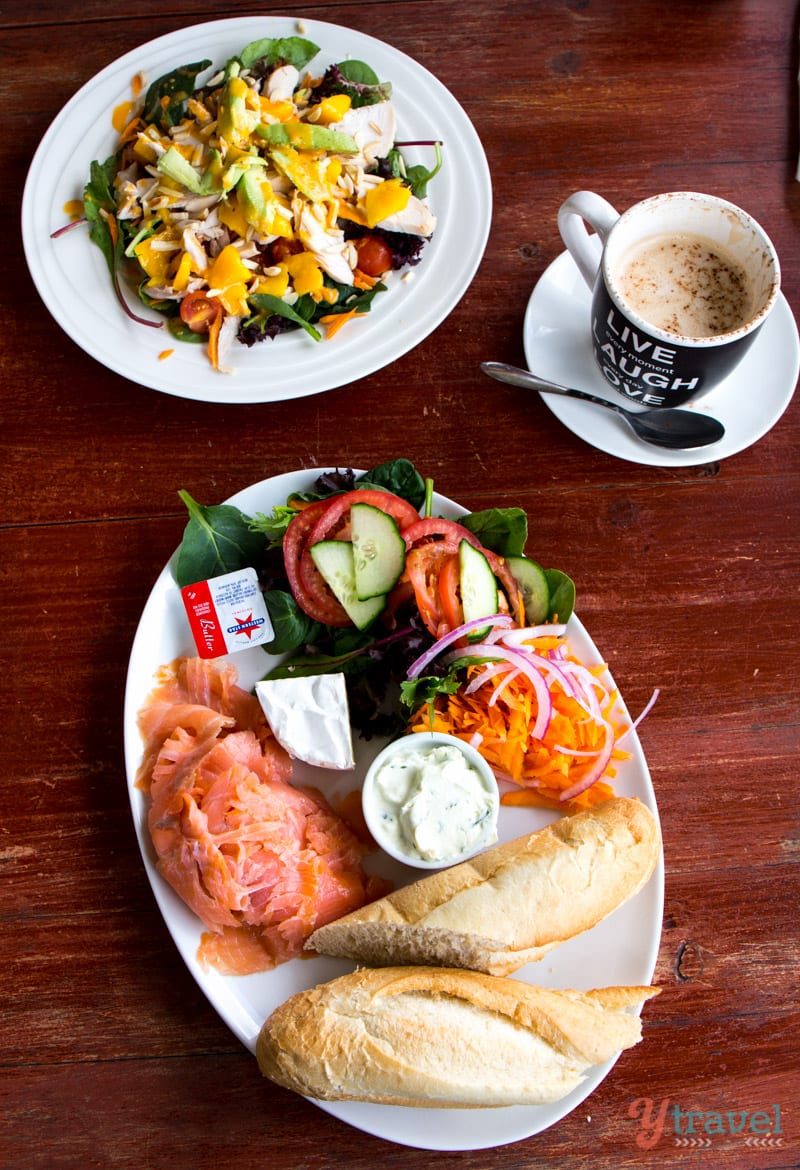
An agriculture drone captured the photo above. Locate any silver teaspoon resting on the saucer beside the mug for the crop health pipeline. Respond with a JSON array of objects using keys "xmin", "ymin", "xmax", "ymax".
[{"xmin": 481, "ymin": 362, "xmax": 725, "ymax": 450}]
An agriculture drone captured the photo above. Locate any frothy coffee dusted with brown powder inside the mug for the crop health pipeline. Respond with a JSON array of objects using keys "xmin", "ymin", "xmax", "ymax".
[{"xmin": 616, "ymin": 232, "xmax": 753, "ymax": 337}]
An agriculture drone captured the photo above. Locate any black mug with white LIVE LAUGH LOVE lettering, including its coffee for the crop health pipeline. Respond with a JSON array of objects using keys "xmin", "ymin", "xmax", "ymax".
[{"xmin": 558, "ymin": 191, "xmax": 780, "ymax": 407}]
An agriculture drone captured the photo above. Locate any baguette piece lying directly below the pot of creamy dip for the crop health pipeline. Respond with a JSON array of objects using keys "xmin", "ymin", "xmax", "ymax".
[{"xmin": 306, "ymin": 797, "xmax": 661, "ymax": 975}]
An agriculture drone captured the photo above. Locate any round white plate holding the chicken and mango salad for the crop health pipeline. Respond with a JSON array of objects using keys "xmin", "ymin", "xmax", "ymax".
[{"xmin": 22, "ymin": 16, "xmax": 491, "ymax": 402}]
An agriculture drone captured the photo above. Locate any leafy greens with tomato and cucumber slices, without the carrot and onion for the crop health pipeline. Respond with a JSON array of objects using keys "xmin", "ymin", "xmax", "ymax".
[{"xmin": 174, "ymin": 459, "xmax": 575, "ymax": 737}]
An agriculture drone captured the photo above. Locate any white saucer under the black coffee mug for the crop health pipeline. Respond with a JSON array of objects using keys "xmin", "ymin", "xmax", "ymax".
[{"xmin": 523, "ymin": 252, "xmax": 800, "ymax": 467}]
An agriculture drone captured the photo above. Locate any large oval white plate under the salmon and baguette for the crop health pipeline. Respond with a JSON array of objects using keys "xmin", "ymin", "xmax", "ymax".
[{"xmin": 124, "ymin": 468, "xmax": 664, "ymax": 1150}]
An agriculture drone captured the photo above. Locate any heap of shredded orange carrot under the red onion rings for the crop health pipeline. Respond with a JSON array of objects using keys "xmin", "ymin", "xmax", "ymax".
[{"xmin": 409, "ymin": 638, "xmax": 628, "ymax": 812}]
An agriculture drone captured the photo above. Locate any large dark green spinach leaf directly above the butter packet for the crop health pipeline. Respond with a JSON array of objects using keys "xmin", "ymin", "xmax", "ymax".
[{"xmin": 175, "ymin": 491, "xmax": 264, "ymax": 589}]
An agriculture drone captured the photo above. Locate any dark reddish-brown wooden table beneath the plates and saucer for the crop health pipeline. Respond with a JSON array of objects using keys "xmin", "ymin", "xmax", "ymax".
[{"xmin": 0, "ymin": 0, "xmax": 800, "ymax": 1170}]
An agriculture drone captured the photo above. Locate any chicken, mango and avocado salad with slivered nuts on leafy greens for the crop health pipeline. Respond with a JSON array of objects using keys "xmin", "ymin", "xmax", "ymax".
[{"xmin": 59, "ymin": 36, "xmax": 442, "ymax": 371}]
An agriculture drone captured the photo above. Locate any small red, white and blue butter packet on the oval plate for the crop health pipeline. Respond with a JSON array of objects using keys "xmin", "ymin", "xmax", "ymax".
[{"xmin": 180, "ymin": 569, "xmax": 275, "ymax": 658}]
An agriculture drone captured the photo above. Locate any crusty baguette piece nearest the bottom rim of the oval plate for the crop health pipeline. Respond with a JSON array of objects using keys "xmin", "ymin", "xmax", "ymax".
[{"xmin": 256, "ymin": 966, "xmax": 658, "ymax": 1108}]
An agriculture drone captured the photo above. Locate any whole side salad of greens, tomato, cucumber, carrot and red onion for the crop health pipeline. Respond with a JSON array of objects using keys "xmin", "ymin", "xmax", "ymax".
[{"xmin": 174, "ymin": 459, "xmax": 655, "ymax": 810}]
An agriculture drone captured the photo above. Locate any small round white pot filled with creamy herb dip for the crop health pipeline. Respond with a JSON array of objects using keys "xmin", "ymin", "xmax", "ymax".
[{"xmin": 364, "ymin": 734, "xmax": 498, "ymax": 865}]
